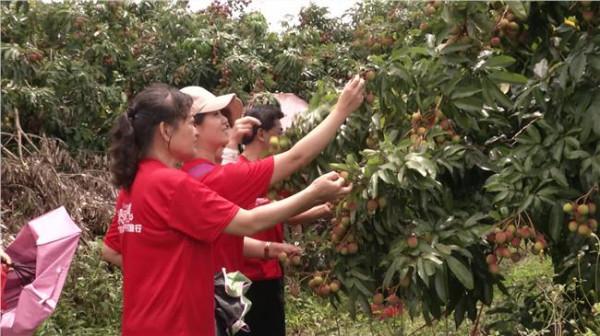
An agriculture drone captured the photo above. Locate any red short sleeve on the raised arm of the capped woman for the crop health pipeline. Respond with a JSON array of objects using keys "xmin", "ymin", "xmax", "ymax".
[{"xmin": 223, "ymin": 156, "xmax": 275, "ymax": 199}]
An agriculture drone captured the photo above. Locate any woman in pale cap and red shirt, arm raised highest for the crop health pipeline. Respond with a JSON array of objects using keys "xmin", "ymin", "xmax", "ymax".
[{"xmin": 181, "ymin": 76, "xmax": 364, "ymax": 272}]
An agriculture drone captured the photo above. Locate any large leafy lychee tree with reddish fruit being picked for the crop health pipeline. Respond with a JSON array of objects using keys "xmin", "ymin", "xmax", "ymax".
[{"xmin": 282, "ymin": 2, "xmax": 600, "ymax": 331}]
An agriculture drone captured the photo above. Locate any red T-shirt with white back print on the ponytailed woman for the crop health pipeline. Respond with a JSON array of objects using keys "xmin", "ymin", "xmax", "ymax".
[{"xmin": 105, "ymin": 160, "xmax": 239, "ymax": 336}]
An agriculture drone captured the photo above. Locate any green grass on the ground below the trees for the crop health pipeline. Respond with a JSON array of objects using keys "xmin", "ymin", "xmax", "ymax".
[{"xmin": 36, "ymin": 253, "xmax": 553, "ymax": 336}]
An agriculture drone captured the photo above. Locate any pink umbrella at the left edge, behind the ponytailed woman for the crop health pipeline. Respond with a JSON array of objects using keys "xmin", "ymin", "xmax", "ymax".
[{"xmin": 0, "ymin": 207, "xmax": 81, "ymax": 336}]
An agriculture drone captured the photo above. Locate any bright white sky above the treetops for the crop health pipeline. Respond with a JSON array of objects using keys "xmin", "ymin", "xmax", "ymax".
[{"xmin": 189, "ymin": 0, "xmax": 359, "ymax": 31}]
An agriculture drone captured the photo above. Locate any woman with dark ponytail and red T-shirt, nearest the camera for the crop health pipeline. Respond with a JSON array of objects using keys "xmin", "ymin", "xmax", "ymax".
[{"xmin": 109, "ymin": 84, "xmax": 350, "ymax": 335}]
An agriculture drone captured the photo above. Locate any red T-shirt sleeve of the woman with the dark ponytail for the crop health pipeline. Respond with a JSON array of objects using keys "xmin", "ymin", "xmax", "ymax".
[{"xmin": 168, "ymin": 177, "xmax": 239, "ymax": 242}]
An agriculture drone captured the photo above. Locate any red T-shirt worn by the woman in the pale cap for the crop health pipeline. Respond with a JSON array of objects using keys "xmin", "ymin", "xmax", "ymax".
[{"xmin": 182, "ymin": 156, "xmax": 274, "ymax": 272}]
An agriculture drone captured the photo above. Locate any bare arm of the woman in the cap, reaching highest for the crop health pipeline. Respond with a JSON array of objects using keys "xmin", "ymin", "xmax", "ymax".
[{"xmin": 271, "ymin": 76, "xmax": 364, "ymax": 184}]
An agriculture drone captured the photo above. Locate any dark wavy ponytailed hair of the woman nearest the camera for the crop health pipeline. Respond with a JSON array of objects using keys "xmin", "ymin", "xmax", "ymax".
[{"xmin": 109, "ymin": 84, "xmax": 192, "ymax": 190}]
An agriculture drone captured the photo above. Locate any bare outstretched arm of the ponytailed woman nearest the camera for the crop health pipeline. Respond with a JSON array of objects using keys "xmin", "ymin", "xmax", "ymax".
[{"xmin": 225, "ymin": 172, "xmax": 352, "ymax": 236}]
